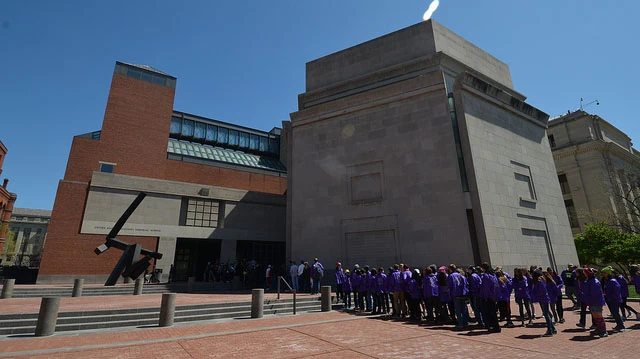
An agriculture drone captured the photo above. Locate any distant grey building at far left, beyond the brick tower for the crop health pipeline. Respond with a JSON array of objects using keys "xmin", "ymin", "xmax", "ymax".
[{"xmin": 1, "ymin": 208, "xmax": 51, "ymax": 268}]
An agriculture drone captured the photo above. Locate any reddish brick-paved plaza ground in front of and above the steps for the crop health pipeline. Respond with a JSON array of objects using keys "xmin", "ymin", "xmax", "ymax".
[{"xmin": 0, "ymin": 294, "xmax": 640, "ymax": 359}]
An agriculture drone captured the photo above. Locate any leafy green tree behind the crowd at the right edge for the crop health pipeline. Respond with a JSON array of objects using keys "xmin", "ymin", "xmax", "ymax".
[{"xmin": 574, "ymin": 223, "xmax": 640, "ymax": 273}]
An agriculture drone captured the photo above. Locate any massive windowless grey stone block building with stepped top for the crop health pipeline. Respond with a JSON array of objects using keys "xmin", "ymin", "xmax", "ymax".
[{"xmin": 284, "ymin": 21, "xmax": 578, "ymax": 270}]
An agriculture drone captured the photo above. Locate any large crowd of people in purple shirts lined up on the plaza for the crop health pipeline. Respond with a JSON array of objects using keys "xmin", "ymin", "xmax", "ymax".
[{"xmin": 335, "ymin": 262, "xmax": 640, "ymax": 337}]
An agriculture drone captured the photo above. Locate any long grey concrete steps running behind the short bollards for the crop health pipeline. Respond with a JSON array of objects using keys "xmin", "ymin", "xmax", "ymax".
[{"xmin": 0, "ymin": 297, "xmax": 320, "ymax": 335}]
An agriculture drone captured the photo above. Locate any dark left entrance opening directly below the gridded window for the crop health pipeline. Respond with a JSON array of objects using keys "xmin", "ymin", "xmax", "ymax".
[{"xmin": 173, "ymin": 238, "xmax": 222, "ymax": 282}]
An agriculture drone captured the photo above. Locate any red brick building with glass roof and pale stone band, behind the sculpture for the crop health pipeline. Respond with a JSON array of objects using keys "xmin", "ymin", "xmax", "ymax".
[{"xmin": 38, "ymin": 62, "xmax": 286, "ymax": 283}]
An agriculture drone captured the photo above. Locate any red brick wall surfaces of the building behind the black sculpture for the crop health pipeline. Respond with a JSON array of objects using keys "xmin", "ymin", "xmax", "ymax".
[{"xmin": 39, "ymin": 66, "xmax": 286, "ymax": 276}]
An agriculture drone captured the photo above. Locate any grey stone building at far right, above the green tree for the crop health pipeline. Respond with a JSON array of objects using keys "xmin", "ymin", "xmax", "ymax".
[{"xmin": 547, "ymin": 110, "xmax": 640, "ymax": 235}]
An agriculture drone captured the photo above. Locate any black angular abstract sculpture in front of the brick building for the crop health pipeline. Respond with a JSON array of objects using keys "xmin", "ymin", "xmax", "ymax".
[{"xmin": 94, "ymin": 192, "xmax": 162, "ymax": 286}]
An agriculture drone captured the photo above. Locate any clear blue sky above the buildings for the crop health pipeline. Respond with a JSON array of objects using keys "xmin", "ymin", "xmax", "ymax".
[{"xmin": 0, "ymin": 0, "xmax": 640, "ymax": 209}]
